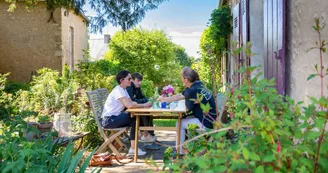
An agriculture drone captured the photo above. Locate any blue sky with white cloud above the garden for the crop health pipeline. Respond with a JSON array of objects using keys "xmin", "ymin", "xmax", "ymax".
[{"xmin": 86, "ymin": 0, "xmax": 219, "ymax": 58}]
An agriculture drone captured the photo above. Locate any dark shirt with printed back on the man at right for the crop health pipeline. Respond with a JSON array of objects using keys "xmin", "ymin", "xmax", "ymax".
[{"xmin": 182, "ymin": 81, "xmax": 216, "ymax": 128}]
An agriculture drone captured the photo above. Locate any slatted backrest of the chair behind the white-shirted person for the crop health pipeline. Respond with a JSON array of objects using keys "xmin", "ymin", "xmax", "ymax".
[{"xmin": 87, "ymin": 88, "xmax": 108, "ymax": 139}]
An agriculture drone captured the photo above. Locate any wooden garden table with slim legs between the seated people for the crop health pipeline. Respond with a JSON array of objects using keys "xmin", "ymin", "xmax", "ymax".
[{"xmin": 127, "ymin": 101, "xmax": 186, "ymax": 162}]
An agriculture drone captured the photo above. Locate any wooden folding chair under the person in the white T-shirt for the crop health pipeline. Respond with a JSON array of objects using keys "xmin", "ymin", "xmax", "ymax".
[{"xmin": 87, "ymin": 88, "xmax": 128, "ymax": 157}]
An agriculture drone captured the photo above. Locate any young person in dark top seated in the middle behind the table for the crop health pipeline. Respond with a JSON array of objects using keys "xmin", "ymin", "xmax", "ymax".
[{"xmin": 126, "ymin": 73, "xmax": 156, "ymax": 144}]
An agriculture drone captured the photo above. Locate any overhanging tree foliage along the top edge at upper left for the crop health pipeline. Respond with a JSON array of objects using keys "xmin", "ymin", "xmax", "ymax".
[{"xmin": 6, "ymin": 0, "xmax": 166, "ymax": 32}]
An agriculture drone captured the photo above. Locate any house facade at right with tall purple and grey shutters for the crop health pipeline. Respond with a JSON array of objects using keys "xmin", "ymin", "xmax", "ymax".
[{"xmin": 220, "ymin": 0, "xmax": 328, "ymax": 104}]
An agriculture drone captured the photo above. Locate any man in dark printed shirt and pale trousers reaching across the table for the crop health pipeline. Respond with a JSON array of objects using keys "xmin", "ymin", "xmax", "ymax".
[{"xmin": 159, "ymin": 67, "xmax": 216, "ymax": 154}]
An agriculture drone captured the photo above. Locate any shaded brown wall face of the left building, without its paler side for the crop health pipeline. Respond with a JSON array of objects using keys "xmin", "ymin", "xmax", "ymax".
[{"xmin": 0, "ymin": 1, "xmax": 62, "ymax": 82}]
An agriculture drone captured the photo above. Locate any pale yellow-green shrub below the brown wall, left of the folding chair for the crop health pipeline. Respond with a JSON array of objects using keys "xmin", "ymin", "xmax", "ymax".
[{"xmin": 17, "ymin": 67, "xmax": 78, "ymax": 115}]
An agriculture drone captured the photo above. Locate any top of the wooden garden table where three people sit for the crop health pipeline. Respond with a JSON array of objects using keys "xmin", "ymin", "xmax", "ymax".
[{"xmin": 126, "ymin": 100, "xmax": 186, "ymax": 113}]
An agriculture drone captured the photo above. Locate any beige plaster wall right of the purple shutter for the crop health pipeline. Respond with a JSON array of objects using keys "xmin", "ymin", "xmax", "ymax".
[{"xmin": 286, "ymin": 0, "xmax": 328, "ymax": 104}]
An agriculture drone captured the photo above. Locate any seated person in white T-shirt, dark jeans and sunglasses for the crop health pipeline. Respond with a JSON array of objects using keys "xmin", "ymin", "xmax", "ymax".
[{"xmin": 102, "ymin": 70, "xmax": 152, "ymax": 155}]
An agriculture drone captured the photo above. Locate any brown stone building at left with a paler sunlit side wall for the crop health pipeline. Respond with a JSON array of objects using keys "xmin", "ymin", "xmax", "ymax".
[{"xmin": 0, "ymin": 0, "xmax": 89, "ymax": 82}]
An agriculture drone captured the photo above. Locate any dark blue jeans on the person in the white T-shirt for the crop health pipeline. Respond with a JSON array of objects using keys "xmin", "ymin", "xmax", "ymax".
[{"xmin": 101, "ymin": 112, "xmax": 136, "ymax": 140}]
